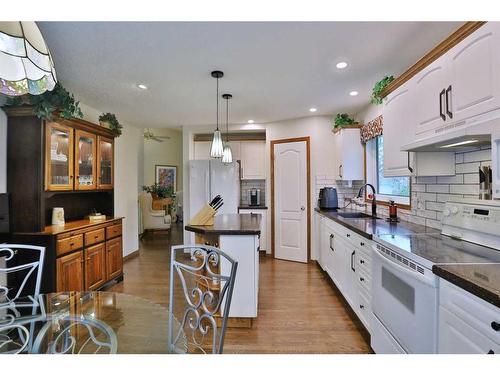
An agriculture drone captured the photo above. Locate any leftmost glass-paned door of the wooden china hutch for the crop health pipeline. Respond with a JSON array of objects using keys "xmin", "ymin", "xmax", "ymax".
[{"xmin": 45, "ymin": 122, "xmax": 73, "ymax": 191}]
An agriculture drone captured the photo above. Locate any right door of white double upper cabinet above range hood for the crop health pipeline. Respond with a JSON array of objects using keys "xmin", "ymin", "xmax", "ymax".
[{"xmin": 445, "ymin": 22, "xmax": 500, "ymax": 121}]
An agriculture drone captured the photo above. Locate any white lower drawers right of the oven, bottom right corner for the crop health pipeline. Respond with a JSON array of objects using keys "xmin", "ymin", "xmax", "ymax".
[{"xmin": 438, "ymin": 279, "xmax": 500, "ymax": 354}]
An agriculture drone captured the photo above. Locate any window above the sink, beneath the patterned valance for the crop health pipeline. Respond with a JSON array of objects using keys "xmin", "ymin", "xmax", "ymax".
[{"xmin": 366, "ymin": 136, "xmax": 410, "ymax": 205}]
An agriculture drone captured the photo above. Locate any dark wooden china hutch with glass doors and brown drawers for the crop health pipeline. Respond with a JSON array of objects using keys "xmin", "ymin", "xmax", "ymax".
[{"xmin": 4, "ymin": 106, "xmax": 123, "ymax": 292}]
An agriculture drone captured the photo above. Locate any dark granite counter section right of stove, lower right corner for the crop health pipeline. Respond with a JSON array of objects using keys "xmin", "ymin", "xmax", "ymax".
[{"xmin": 432, "ymin": 263, "xmax": 500, "ymax": 308}]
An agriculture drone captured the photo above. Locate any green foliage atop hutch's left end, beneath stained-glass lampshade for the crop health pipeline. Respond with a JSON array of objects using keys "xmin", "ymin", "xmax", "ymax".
[{"xmin": 6, "ymin": 82, "xmax": 83, "ymax": 120}]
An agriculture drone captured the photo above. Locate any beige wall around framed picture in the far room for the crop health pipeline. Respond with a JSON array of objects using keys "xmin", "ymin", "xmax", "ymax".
[{"xmin": 143, "ymin": 129, "xmax": 183, "ymax": 191}]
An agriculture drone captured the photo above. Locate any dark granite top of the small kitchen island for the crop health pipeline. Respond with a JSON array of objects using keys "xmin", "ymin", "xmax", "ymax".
[{"xmin": 185, "ymin": 214, "xmax": 261, "ymax": 236}]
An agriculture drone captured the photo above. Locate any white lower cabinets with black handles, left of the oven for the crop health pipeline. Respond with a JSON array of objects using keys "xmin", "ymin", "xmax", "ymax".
[{"xmin": 314, "ymin": 217, "xmax": 371, "ymax": 332}]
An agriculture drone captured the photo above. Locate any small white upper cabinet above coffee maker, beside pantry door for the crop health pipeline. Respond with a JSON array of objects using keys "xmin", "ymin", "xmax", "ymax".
[{"xmin": 240, "ymin": 141, "xmax": 266, "ymax": 180}]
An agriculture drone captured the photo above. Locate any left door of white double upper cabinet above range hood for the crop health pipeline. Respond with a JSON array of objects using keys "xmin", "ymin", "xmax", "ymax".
[{"xmin": 414, "ymin": 56, "xmax": 448, "ymax": 138}]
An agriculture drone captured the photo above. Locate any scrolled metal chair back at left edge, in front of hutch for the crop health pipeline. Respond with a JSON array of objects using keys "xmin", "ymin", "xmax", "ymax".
[{"xmin": 0, "ymin": 244, "xmax": 45, "ymax": 307}]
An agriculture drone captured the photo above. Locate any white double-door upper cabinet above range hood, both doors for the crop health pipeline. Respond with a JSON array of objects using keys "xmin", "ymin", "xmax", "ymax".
[{"xmin": 409, "ymin": 22, "xmax": 500, "ymax": 140}]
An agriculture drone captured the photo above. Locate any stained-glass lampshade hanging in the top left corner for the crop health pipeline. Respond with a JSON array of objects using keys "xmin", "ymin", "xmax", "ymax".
[{"xmin": 0, "ymin": 22, "xmax": 57, "ymax": 96}]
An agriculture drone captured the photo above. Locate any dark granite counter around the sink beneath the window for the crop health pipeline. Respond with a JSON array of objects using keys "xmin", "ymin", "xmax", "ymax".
[{"xmin": 315, "ymin": 208, "xmax": 439, "ymax": 240}]
